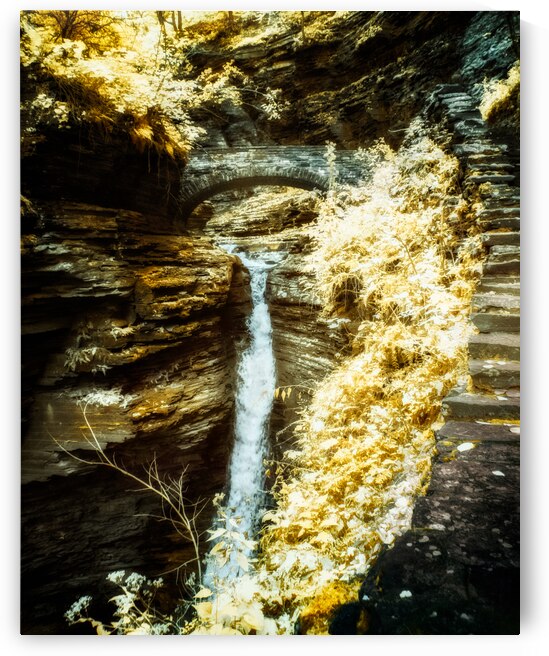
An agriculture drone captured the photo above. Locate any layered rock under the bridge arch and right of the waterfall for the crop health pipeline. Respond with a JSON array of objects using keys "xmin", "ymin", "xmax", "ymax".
[{"xmin": 189, "ymin": 187, "xmax": 349, "ymax": 459}]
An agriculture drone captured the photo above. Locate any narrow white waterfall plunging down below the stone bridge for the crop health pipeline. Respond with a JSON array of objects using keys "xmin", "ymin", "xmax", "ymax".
[{"xmin": 204, "ymin": 246, "xmax": 285, "ymax": 588}]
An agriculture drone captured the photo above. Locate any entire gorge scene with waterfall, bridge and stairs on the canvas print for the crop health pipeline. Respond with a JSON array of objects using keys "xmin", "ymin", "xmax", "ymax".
[{"xmin": 21, "ymin": 10, "xmax": 520, "ymax": 635}]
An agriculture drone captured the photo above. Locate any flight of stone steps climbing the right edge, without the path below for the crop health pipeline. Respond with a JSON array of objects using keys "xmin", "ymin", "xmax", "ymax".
[{"xmin": 437, "ymin": 85, "xmax": 520, "ymax": 436}]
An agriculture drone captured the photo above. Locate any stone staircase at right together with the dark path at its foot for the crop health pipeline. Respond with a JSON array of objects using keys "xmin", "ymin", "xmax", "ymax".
[{"xmin": 354, "ymin": 84, "xmax": 520, "ymax": 635}]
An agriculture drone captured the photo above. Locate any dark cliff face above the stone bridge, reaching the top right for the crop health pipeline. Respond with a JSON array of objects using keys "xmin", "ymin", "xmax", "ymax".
[{"xmin": 186, "ymin": 11, "xmax": 519, "ymax": 148}]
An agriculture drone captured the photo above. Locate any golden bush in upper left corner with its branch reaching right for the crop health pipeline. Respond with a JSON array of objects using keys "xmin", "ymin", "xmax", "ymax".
[{"xmin": 21, "ymin": 11, "xmax": 255, "ymax": 159}]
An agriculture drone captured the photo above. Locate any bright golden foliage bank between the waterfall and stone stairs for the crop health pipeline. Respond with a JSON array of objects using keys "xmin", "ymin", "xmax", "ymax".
[{"xmin": 252, "ymin": 123, "xmax": 475, "ymax": 624}]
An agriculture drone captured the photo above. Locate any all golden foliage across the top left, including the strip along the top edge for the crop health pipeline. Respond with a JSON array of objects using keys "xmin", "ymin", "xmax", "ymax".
[{"xmin": 21, "ymin": 10, "xmax": 334, "ymax": 160}]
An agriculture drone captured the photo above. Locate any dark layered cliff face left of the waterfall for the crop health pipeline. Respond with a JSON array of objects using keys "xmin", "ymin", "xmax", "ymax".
[{"xmin": 22, "ymin": 125, "xmax": 247, "ymax": 633}]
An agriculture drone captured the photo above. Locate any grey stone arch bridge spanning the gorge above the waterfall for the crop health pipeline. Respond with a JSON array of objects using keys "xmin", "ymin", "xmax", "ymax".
[{"xmin": 180, "ymin": 146, "xmax": 364, "ymax": 220}]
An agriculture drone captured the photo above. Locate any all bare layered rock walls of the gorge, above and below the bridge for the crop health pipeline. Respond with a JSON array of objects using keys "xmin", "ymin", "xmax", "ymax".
[{"xmin": 21, "ymin": 12, "xmax": 517, "ymax": 633}]
